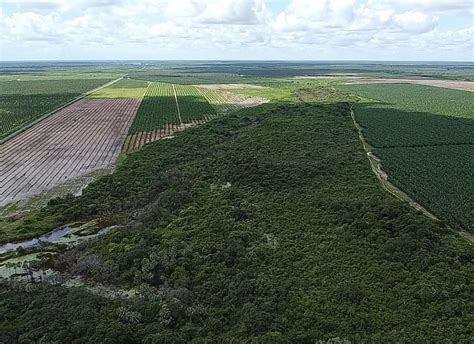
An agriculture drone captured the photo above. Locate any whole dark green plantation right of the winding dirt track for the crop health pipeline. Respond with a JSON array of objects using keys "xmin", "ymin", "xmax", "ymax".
[{"xmin": 338, "ymin": 84, "xmax": 474, "ymax": 230}]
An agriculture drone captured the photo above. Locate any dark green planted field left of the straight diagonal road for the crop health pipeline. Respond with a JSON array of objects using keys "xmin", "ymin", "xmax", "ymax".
[{"xmin": 0, "ymin": 73, "xmax": 118, "ymax": 139}]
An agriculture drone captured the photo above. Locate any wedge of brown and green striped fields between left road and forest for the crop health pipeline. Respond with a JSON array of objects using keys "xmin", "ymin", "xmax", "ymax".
[{"xmin": 0, "ymin": 78, "xmax": 265, "ymax": 206}]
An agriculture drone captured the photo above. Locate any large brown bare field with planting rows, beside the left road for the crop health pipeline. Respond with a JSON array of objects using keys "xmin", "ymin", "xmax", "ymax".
[{"xmin": 0, "ymin": 98, "xmax": 141, "ymax": 206}]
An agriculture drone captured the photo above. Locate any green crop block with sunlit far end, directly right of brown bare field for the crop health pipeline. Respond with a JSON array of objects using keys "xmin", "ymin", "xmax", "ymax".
[{"xmin": 129, "ymin": 82, "xmax": 179, "ymax": 134}]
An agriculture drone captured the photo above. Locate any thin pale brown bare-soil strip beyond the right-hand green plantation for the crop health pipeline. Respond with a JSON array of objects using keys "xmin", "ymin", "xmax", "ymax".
[{"xmin": 298, "ymin": 75, "xmax": 474, "ymax": 92}]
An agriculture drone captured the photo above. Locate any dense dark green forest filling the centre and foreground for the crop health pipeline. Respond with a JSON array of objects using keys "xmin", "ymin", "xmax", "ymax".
[{"xmin": 0, "ymin": 86, "xmax": 474, "ymax": 343}]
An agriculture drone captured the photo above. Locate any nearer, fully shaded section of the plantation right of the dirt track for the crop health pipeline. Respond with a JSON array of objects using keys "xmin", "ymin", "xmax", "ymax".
[{"xmin": 376, "ymin": 145, "xmax": 474, "ymax": 230}]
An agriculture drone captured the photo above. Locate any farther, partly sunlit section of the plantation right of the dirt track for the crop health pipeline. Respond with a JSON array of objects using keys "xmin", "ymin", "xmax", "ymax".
[{"xmin": 341, "ymin": 84, "xmax": 474, "ymax": 147}]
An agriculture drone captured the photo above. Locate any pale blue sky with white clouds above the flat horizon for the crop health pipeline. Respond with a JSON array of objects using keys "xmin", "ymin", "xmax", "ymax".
[{"xmin": 0, "ymin": 0, "xmax": 474, "ymax": 61}]
